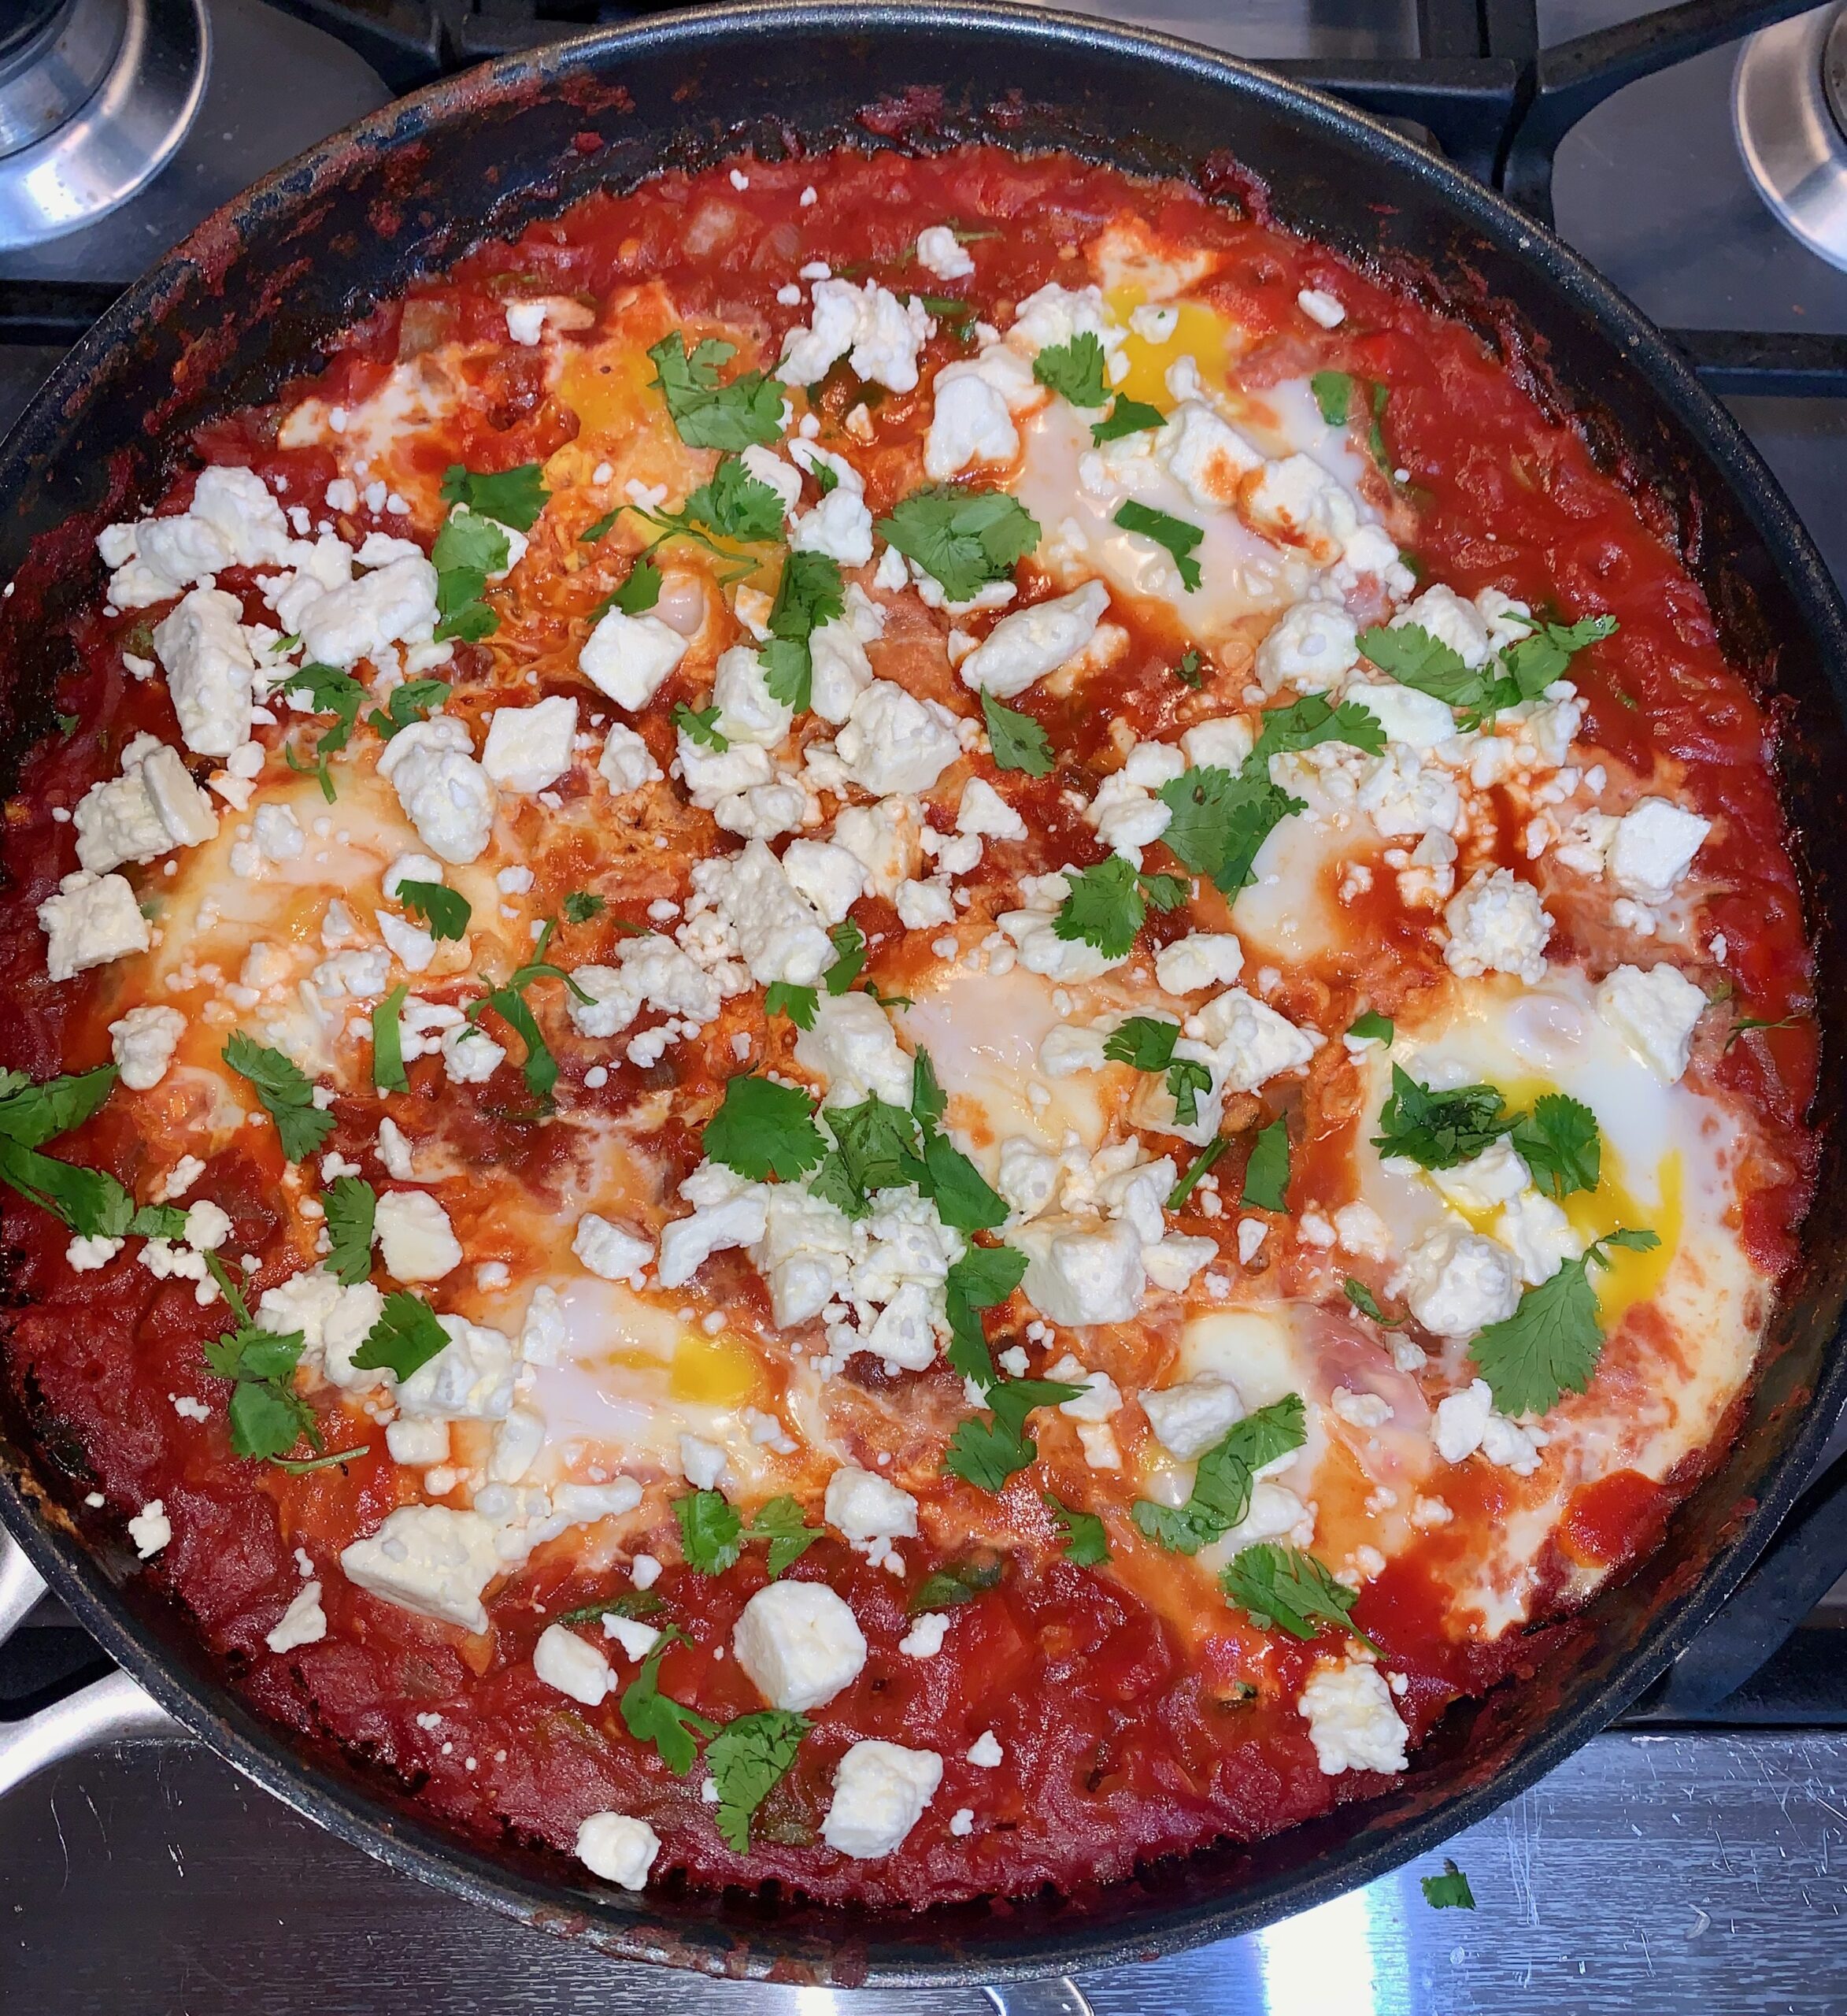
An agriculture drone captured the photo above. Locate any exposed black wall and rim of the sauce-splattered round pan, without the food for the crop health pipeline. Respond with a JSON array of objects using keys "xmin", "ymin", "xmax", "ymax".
[{"xmin": 0, "ymin": 6, "xmax": 1847, "ymax": 1986}]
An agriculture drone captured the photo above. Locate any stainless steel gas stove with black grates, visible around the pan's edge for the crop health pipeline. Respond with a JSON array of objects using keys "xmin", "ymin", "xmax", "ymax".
[{"xmin": 0, "ymin": 0, "xmax": 1847, "ymax": 2016}]
